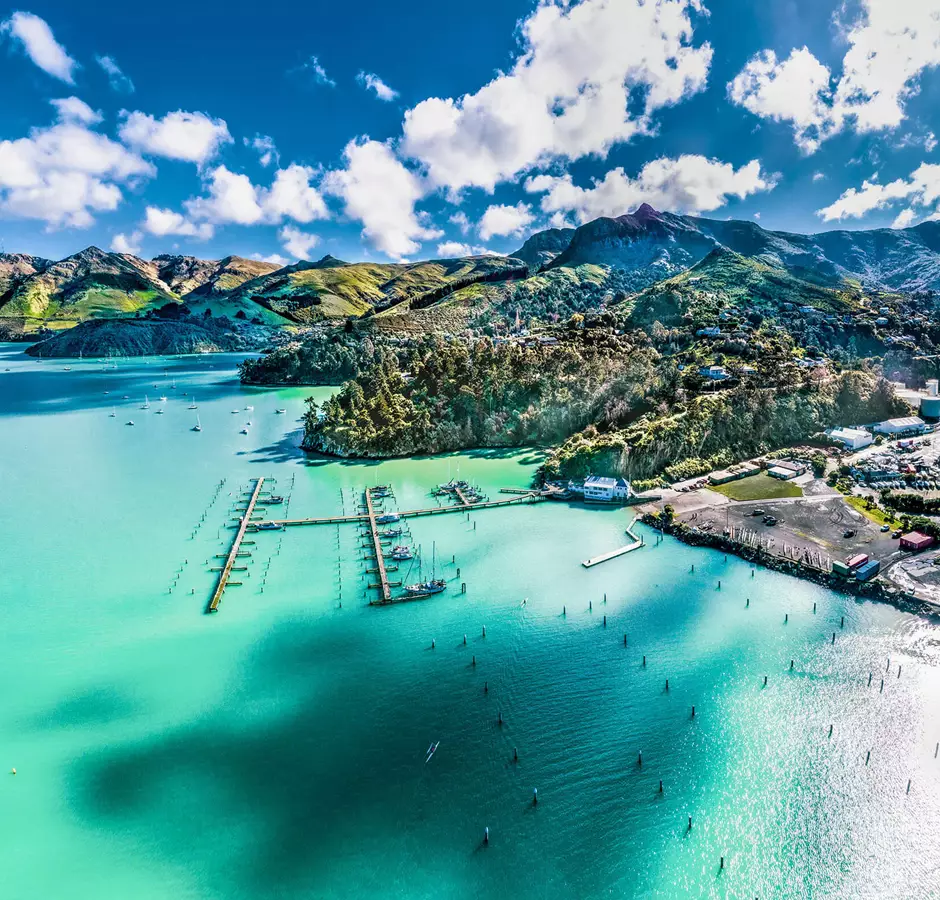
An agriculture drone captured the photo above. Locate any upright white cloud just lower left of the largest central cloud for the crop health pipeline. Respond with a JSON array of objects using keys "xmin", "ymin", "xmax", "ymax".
[{"xmin": 323, "ymin": 139, "xmax": 441, "ymax": 259}]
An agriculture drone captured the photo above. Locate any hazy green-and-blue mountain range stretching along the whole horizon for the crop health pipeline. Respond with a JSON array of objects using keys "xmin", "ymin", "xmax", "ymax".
[{"xmin": 0, "ymin": 204, "xmax": 940, "ymax": 348}]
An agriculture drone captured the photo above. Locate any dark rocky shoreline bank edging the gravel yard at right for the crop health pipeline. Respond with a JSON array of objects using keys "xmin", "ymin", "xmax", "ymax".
[{"xmin": 640, "ymin": 512, "xmax": 940, "ymax": 622}]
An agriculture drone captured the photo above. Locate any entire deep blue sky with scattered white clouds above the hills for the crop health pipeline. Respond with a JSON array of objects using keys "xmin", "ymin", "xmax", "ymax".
[{"xmin": 0, "ymin": 0, "xmax": 940, "ymax": 261}]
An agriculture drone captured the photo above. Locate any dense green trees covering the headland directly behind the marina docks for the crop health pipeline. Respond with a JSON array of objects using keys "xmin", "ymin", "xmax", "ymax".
[{"xmin": 304, "ymin": 329, "xmax": 658, "ymax": 456}]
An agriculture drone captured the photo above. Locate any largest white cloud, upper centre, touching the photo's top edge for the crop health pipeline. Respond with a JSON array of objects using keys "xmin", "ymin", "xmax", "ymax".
[{"xmin": 401, "ymin": 0, "xmax": 712, "ymax": 192}]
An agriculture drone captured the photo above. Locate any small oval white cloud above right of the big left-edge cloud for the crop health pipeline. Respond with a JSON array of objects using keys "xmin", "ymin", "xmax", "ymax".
[{"xmin": 118, "ymin": 110, "xmax": 232, "ymax": 165}]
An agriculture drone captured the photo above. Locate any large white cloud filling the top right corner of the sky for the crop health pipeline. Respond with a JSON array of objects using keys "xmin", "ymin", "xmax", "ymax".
[{"xmin": 728, "ymin": 0, "xmax": 940, "ymax": 153}]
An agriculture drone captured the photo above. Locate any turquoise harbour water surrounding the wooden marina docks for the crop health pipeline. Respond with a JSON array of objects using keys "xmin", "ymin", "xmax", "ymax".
[{"xmin": 0, "ymin": 345, "xmax": 940, "ymax": 900}]
